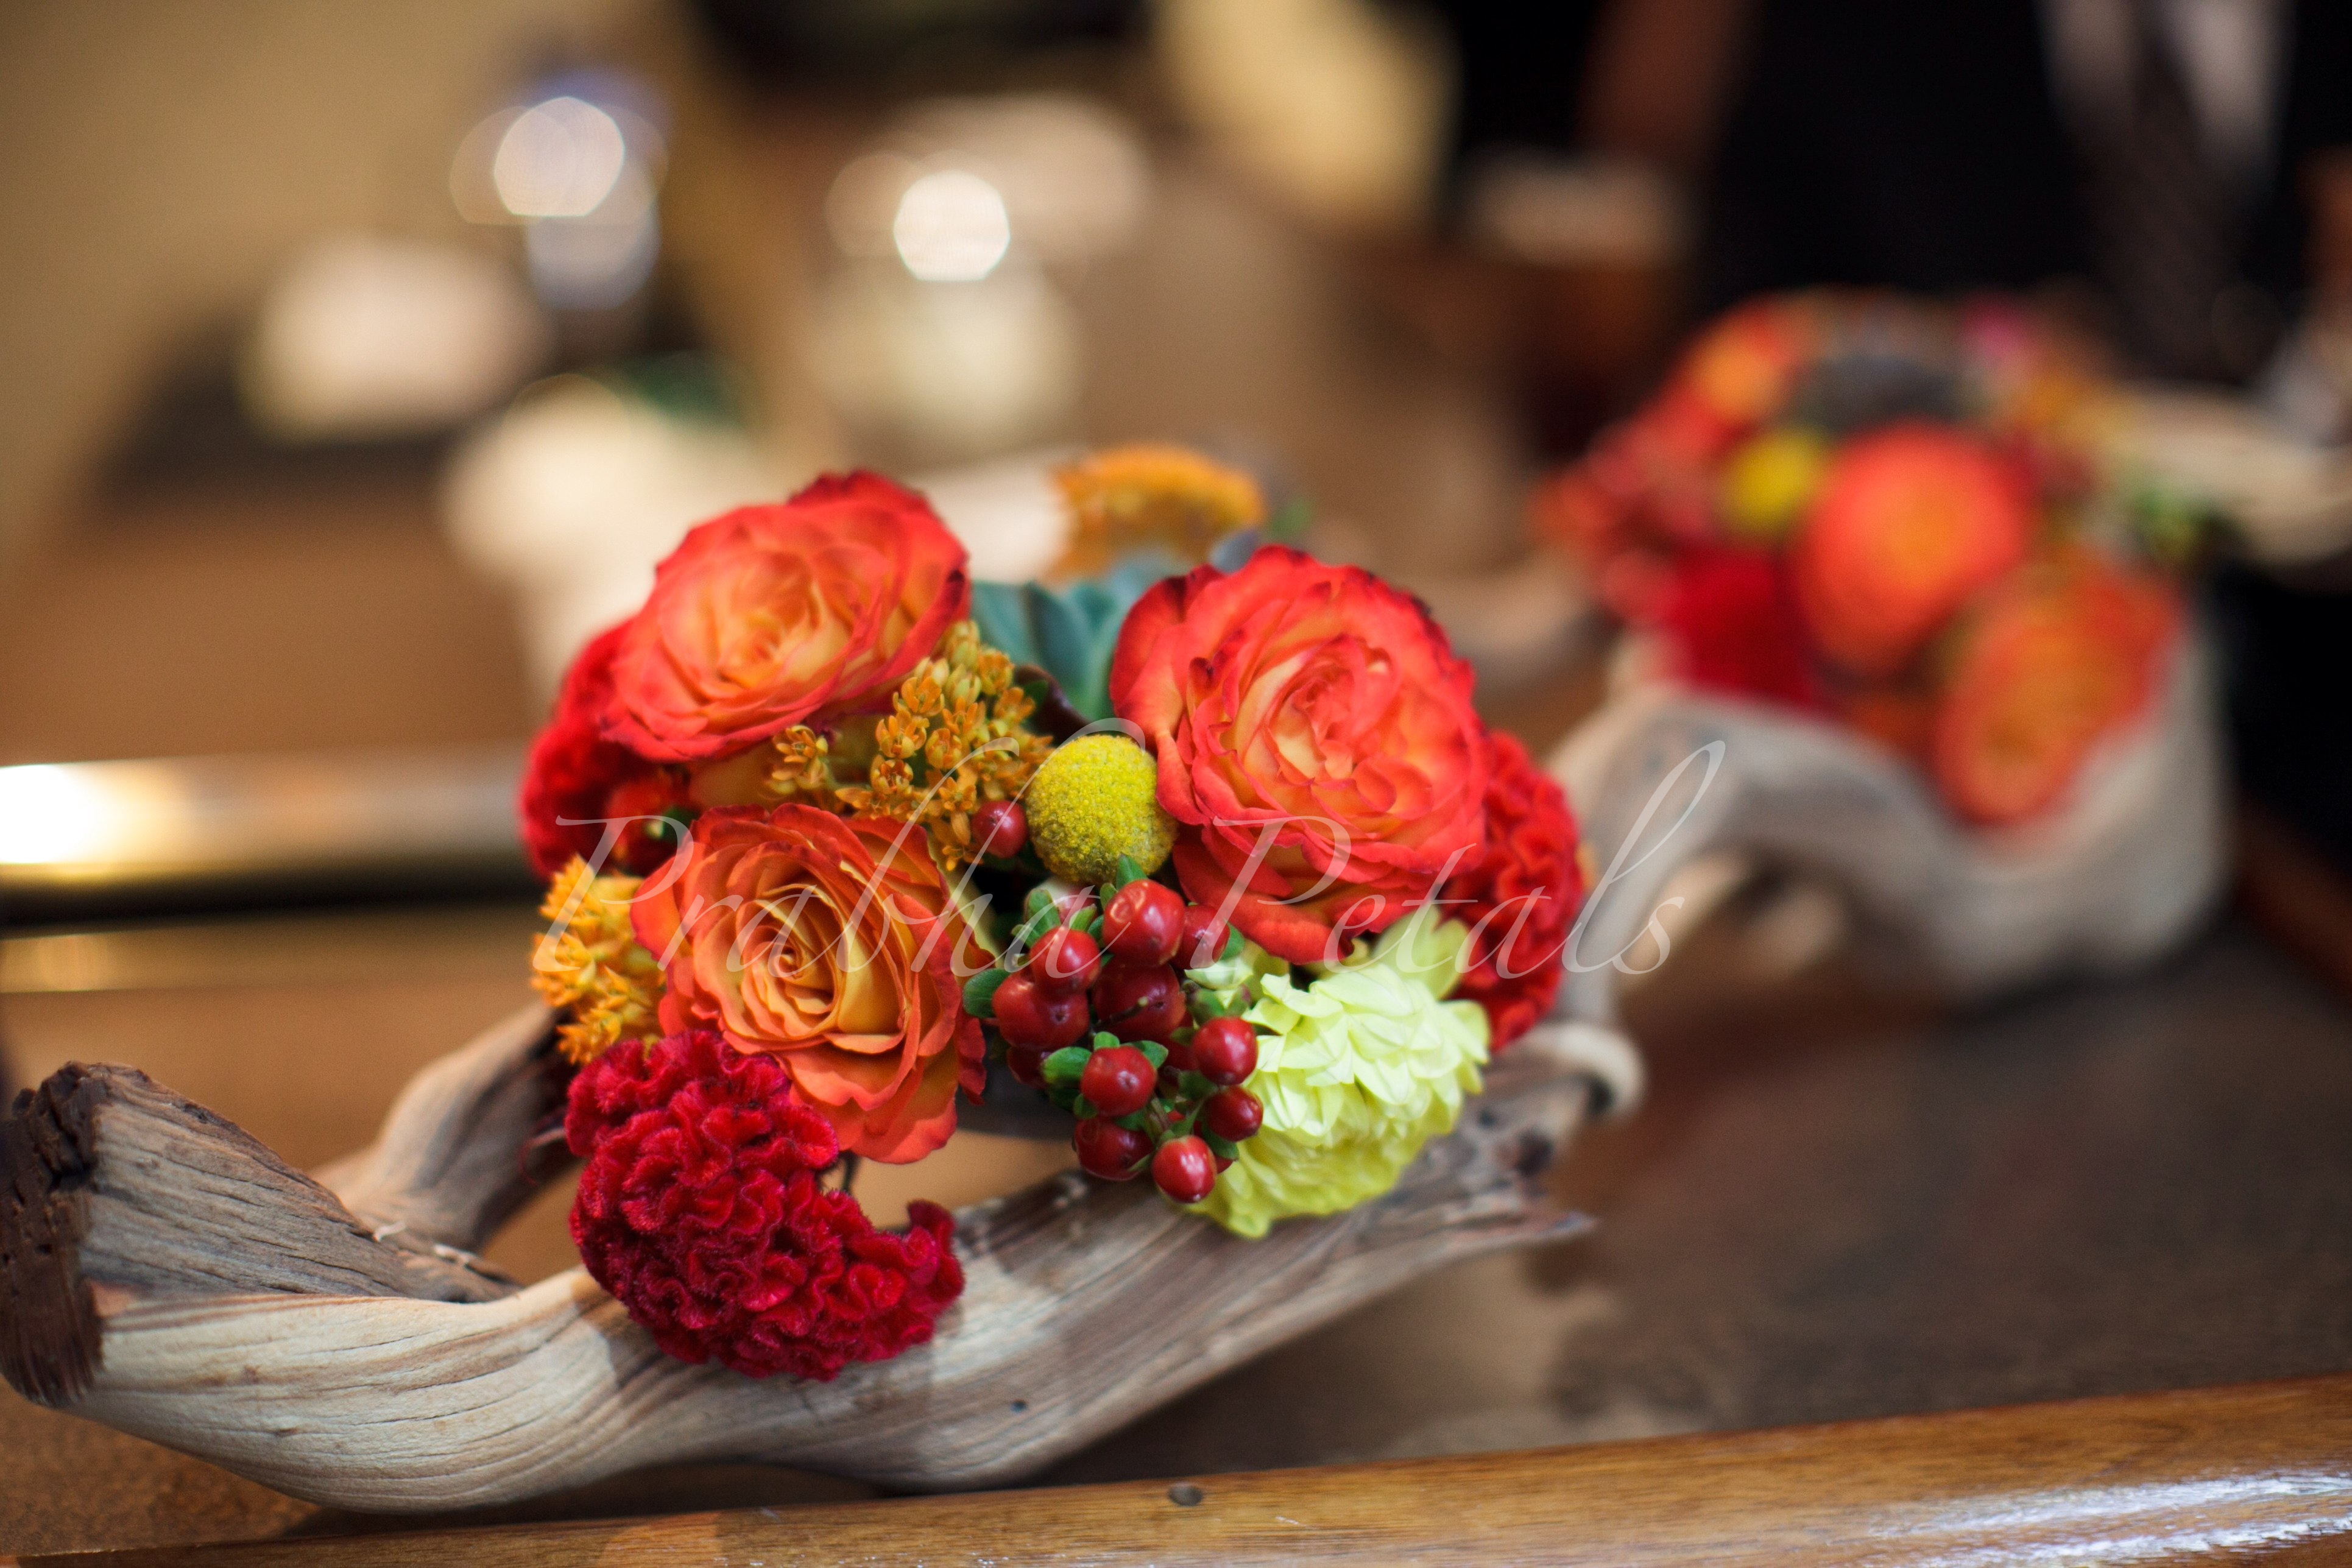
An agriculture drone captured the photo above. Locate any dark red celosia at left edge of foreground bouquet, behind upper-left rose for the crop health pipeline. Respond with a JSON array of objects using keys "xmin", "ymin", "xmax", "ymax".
[{"xmin": 517, "ymin": 626, "xmax": 685, "ymax": 877}]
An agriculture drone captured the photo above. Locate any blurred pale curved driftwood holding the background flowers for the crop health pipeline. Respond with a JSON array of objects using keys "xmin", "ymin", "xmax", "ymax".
[{"xmin": 1550, "ymin": 635, "xmax": 2230, "ymax": 1023}]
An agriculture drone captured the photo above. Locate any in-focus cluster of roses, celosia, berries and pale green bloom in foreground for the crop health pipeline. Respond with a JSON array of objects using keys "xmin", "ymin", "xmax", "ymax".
[{"xmin": 520, "ymin": 447, "xmax": 1585, "ymax": 1377}]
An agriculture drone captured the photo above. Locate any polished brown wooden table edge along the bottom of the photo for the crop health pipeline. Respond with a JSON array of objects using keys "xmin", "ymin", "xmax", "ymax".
[{"xmin": 21, "ymin": 1376, "xmax": 2352, "ymax": 1568}]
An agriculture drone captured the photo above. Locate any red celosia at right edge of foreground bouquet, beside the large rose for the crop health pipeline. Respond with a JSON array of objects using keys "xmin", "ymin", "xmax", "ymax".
[{"xmin": 1444, "ymin": 733, "xmax": 1585, "ymax": 1051}]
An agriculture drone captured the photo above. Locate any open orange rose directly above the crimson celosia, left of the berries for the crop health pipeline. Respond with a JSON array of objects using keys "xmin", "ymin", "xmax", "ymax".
[{"xmin": 635, "ymin": 807, "xmax": 988, "ymax": 1164}]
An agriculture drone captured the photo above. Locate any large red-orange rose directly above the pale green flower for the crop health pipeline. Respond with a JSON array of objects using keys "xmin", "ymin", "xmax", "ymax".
[{"xmin": 1110, "ymin": 548, "xmax": 1486, "ymax": 964}]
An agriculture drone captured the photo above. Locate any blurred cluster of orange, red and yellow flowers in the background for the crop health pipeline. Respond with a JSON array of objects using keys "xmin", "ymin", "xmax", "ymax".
[{"xmin": 1533, "ymin": 294, "xmax": 2183, "ymax": 825}]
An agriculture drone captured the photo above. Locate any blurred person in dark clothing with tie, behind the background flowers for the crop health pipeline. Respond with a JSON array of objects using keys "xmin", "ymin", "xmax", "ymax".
[{"xmin": 1703, "ymin": 0, "xmax": 2352, "ymax": 378}]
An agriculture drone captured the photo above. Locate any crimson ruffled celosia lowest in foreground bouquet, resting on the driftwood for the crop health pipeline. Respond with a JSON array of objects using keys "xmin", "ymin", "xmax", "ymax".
[{"xmin": 565, "ymin": 1029, "xmax": 964, "ymax": 1382}]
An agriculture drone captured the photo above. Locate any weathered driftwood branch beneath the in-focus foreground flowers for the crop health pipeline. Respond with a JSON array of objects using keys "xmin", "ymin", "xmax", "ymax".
[{"xmin": 0, "ymin": 1015, "xmax": 1630, "ymax": 1510}]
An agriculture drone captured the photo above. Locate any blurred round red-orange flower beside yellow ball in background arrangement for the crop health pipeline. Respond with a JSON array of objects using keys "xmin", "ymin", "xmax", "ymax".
[{"xmin": 1790, "ymin": 423, "xmax": 2035, "ymax": 677}]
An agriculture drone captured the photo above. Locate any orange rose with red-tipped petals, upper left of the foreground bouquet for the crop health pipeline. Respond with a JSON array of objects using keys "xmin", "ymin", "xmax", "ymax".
[{"xmin": 604, "ymin": 473, "xmax": 972, "ymax": 761}]
